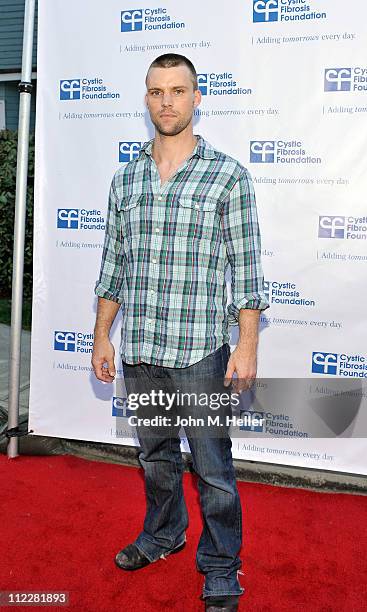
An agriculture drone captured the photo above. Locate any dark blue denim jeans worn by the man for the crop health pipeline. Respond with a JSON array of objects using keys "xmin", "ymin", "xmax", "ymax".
[{"xmin": 122, "ymin": 344, "xmax": 244, "ymax": 598}]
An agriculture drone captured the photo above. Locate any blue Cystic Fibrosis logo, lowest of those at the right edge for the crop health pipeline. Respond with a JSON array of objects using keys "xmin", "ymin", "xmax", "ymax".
[{"xmin": 311, "ymin": 351, "xmax": 367, "ymax": 378}]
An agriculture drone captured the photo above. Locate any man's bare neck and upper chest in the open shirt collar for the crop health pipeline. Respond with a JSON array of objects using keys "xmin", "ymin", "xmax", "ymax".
[{"xmin": 152, "ymin": 131, "xmax": 197, "ymax": 166}]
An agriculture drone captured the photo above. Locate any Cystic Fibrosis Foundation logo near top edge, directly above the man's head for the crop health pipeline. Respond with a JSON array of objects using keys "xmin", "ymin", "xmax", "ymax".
[{"xmin": 121, "ymin": 7, "xmax": 186, "ymax": 33}]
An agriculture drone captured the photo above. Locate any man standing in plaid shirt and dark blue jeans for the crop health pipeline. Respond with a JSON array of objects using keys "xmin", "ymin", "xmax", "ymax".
[{"xmin": 92, "ymin": 54, "xmax": 268, "ymax": 612}]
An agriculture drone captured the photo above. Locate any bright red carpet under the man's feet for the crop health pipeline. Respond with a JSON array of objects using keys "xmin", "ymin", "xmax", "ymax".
[{"xmin": 0, "ymin": 455, "xmax": 367, "ymax": 612}]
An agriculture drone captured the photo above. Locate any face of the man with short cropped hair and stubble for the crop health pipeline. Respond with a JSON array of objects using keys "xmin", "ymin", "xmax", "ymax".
[{"xmin": 145, "ymin": 65, "xmax": 201, "ymax": 136}]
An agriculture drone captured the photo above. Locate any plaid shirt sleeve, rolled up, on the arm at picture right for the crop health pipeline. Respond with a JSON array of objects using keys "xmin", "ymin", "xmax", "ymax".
[{"xmin": 222, "ymin": 168, "xmax": 269, "ymax": 325}]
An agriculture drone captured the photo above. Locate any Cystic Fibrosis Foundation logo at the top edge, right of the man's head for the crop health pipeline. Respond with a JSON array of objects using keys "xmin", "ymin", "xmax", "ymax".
[{"xmin": 252, "ymin": 0, "xmax": 326, "ymax": 23}]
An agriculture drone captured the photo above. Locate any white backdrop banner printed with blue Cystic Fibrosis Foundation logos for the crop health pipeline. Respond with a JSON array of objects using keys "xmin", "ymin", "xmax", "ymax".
[{"xmin": 30, "ymin": 0, "xmax": 367, "ymax": 474}]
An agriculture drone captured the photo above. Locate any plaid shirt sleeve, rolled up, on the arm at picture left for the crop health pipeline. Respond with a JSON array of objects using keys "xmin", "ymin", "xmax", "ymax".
[{"xmin": 94, "ymin": 177, "xmax": 124, "ymax": 304}]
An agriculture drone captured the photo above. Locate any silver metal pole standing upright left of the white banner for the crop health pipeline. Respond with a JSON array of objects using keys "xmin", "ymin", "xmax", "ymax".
[{"xmin": 7, "ymin": 0, "xmax": 35, "ymax": 458}]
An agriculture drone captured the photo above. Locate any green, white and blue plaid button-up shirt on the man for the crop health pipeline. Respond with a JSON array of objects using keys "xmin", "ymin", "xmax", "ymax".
[{"xmin": 95, "ymin": 136, "xmax": 269, "ymax": 368}]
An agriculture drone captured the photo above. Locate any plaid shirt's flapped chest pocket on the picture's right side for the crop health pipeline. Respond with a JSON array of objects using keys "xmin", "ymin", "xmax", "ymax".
[{"xmin": 176, "ymin": 196, "xmax": 220, "ymax": 240}]
